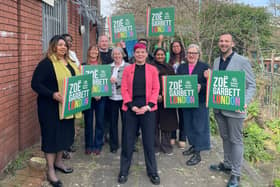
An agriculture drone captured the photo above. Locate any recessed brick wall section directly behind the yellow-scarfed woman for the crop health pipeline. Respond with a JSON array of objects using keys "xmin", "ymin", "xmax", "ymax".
[{"xmin": 19, "ymin": 0, "xmax": 42, "ymax": 150}]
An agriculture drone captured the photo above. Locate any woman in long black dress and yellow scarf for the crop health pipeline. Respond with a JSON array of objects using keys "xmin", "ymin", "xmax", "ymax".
[{"xmin": 31, "ymin": 35, "xmax": 80, "ymax": 187}]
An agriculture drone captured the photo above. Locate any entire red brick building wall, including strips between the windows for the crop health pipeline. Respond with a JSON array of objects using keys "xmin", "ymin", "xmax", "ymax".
[{"xmin": 0, "ymin": 0, "xmax": 98, "ymax": 171}]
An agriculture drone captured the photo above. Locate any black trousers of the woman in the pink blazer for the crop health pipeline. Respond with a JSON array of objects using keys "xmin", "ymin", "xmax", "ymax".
[{"xmin": 120, "ymin": 109, "xmax": 157, "ymax": 175}]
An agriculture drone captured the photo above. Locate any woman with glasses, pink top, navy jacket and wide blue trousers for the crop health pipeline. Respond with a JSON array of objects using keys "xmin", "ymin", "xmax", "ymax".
[{"xmin": 177, "ymin": 44, "xmax": 210, "ymax": 166}]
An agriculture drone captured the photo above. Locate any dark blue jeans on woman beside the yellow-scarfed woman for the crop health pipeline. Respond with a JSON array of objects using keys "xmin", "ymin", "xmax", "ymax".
[{"xmin": 84, "ymin": 97, "xmax": 105, "ymax": 151}]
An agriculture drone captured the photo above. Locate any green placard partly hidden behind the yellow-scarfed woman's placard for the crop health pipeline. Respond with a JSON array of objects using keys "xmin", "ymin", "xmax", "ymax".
[{"xmin": 81, "ymin": 65, "xmax": 112, "ymax": 97}]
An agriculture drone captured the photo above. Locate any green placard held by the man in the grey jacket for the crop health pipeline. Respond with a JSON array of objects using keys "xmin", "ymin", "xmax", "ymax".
[{"xmin": 206, "ymin": 71, "xmax": 245, "ymax": 111}]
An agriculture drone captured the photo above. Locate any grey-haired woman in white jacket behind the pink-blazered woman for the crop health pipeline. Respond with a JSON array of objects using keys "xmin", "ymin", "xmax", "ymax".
[{"xmin": 109, "ymin": 47, "xmax": 129, "ymax": 153}]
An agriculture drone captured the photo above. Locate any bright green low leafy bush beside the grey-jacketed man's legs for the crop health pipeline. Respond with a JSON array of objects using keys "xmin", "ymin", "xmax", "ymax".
[{"xmin": 244, "ymin": 123, "xmax": 272, "ymax": 162}]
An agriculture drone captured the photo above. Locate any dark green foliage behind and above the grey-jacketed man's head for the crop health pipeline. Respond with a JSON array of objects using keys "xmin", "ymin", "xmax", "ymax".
[{"xmin": 200, "ymin": 3, "xmax": 271, "ymax": 63}]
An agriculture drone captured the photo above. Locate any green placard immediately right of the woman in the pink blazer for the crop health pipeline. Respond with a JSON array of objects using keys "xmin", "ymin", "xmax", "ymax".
[{"xmin": 162, "ymin": 75, "xmax": 198, "ymax": 108}]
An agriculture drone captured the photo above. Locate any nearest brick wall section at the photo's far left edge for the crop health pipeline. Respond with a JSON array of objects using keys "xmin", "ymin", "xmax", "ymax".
[{"xmin": 0, "ymin": 1, "xmax": 19, "ymax": 171}]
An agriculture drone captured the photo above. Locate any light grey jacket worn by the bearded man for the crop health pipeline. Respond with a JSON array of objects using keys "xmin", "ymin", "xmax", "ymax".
[{"xmin": 213, "ymin": 53, "xmax": 256, "ymax": 118}]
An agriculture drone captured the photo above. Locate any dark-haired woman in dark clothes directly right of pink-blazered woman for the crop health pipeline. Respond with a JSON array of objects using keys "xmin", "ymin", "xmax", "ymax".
[{"xmin": 152, "ymin": 48, "xmax": 178, "ymax": 155}]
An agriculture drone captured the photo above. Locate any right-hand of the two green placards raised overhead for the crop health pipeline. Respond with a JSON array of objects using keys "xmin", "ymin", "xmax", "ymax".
[{"xmin": 147, "ymin": 7, "xmax": 175, "ymax": 36}]
